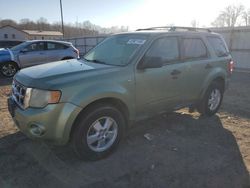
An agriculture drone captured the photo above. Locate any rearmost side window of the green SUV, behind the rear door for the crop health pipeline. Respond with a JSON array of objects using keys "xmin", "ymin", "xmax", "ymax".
[{"xmin": 207, "ymin": 37, "xmax": 228, "ymax": 57}]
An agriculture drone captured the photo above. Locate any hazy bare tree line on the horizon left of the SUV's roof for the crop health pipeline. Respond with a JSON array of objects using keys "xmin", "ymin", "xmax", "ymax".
[{"xmin": 0, "ymin": 17, "xmax": 128, "ymax": 38}]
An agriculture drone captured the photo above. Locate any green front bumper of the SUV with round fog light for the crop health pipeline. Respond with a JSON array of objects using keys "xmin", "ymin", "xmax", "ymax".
[{"xmin": 8, "ymin": 97, "xmax": 82, "ymax": 145}]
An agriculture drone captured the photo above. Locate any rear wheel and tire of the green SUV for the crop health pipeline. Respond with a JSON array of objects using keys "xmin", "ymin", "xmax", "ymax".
[{"xmin": 197, "ymin": 82, "xmax": 224, "ymax": 117}]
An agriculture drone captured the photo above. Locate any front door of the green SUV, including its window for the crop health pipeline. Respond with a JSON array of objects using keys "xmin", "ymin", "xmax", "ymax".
[{"xmin": 135, "ymin": 37, "xmax": 184, "ymax": 118}]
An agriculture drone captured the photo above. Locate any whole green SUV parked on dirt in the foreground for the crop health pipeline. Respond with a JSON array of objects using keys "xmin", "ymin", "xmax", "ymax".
[{"xmin": 8, "ymin": 27, "xmax": 233, "ymax": 160}]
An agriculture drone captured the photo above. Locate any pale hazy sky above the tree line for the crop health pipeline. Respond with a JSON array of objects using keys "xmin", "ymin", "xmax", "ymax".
[{"xmin": 0, "ymin": 0, "xmax": 250, "ymax": 30}]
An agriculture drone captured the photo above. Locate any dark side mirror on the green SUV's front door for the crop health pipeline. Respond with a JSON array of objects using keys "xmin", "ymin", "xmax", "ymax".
[{"xmin": 138, "ymin": 57, "xmax": 163, "ymax": 69}]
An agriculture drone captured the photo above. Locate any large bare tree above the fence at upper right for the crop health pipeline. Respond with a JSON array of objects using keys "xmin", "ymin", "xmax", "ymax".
[{"xmin": 212, "ymin": 5, "xmax": 245, "ymax": 27}]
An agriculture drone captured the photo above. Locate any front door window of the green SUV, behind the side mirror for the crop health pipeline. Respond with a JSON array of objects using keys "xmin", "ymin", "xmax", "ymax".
[{"xmin": 145, "ymin": 37, "xmax": 179, "ymax": 63}]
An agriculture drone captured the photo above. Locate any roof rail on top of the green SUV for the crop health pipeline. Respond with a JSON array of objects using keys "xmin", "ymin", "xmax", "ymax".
[{"xmin": 136, "ymin": 26, "xmax": 212, "ymax": 33}]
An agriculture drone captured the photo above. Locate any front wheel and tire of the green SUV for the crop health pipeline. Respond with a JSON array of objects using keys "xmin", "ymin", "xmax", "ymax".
[{"xmin": 72, "ymin": 105, "xmax": 125, "ymax": 161}]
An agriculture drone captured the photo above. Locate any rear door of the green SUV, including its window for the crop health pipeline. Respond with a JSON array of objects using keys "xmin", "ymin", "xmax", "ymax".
[{"xmin": 180, "ymin": 36, "xmax": 213, "ymax": 103}]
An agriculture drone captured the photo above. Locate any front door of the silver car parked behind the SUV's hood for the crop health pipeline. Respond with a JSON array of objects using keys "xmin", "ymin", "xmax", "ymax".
[{"xmin": 18, "ymin": 42, "xmax": 47, "ymax": 67}]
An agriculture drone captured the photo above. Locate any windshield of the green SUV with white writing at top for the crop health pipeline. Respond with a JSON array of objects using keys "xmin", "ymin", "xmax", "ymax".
[{"xmin": 84, "ymin": 35, "xmax": 147, "ymax": 66}]
